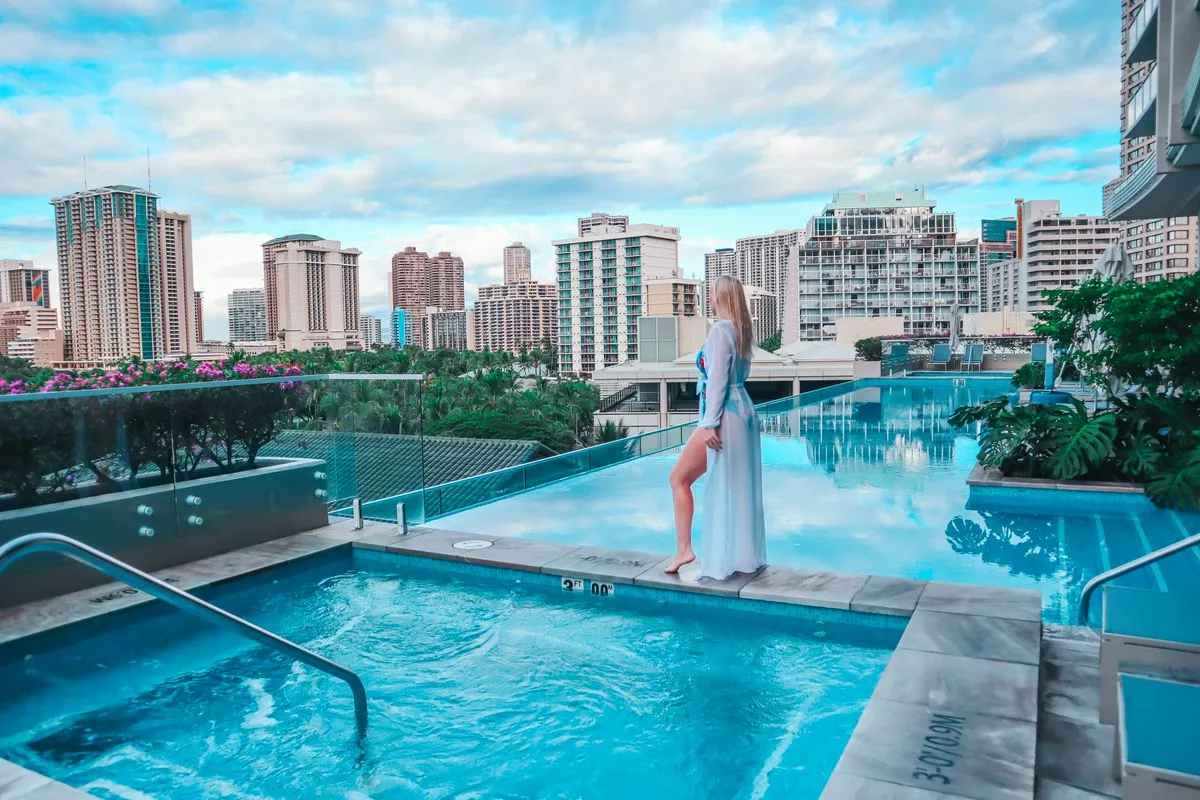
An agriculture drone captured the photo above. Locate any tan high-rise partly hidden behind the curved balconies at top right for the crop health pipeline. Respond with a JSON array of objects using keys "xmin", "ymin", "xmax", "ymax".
[{"xmin": 1105, "ymin": 0, "xmax": 1200, "ymax": 282}]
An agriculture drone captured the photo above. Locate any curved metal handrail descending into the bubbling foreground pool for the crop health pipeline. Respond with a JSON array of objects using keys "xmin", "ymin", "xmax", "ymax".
[{"xmin": 0, "ymin": 534, "xmax": 367, "ymax": 738}]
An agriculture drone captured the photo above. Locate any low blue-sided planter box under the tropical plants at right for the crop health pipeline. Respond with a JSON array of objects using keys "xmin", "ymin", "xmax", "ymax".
[{"xmin": 967, "ymin": 464, "xmax": 1154, "ymax": 513}]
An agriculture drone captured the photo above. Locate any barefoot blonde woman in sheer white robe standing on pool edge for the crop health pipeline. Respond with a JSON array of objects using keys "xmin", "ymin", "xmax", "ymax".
[{"xmin": 666, "ymin": 275, "xmax": 767, "ymax": 579}]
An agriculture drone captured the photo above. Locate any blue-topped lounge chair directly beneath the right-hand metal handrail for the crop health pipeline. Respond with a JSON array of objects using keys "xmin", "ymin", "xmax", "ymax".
[{"xmin": 1100, "ymin": 587, "xmax": 1200, "ymax": 729}]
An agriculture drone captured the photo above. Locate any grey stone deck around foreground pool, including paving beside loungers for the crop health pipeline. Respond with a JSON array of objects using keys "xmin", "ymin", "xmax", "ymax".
[{"xmin": 0, "ymin": 521, "xmax": 1118, "ymax": 800}]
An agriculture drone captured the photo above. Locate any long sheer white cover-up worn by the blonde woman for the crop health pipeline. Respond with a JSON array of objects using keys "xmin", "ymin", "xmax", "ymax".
[{"xmin": 696, "ymin": 320, "xmax": 767, "ymax": 579}]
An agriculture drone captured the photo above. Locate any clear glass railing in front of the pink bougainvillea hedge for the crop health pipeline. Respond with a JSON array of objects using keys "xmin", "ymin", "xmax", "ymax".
[{"xmin": 0, "ymin": 365, "xmax": 422, "ymax": 607}]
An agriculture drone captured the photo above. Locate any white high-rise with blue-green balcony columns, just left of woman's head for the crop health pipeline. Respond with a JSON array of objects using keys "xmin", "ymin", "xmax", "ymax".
[{"xmin": 553, "ymin": 215, "xmax": 679, "ymax": 375}]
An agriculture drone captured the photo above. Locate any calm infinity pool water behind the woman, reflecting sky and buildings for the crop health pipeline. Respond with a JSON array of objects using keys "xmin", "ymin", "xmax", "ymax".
[{"xmin": 433, "ymin": 379, "xmax": 1200, "ymax": 624}]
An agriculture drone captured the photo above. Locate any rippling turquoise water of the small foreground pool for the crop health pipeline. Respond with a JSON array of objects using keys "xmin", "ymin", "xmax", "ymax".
[{"xmin": 0, "ymin": 555, "xmax": 899, "ymax": 800}]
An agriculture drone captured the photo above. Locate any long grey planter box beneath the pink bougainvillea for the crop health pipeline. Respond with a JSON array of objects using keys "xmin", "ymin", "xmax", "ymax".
[{"xmin": 0, "ymin": 458, "xmax": 329, "ymax": 607}]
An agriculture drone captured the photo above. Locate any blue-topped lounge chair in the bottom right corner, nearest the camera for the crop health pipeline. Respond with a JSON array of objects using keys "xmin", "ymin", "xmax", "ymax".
[{"xmin": 1112, "ymin": 675, "xmax": 1200, "ymax": 800}]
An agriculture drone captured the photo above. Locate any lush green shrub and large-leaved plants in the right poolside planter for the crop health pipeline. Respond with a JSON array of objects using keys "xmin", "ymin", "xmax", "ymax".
[{"xmin": 949, "ymin": 275, "xmax": 1200, "ymax": 509}]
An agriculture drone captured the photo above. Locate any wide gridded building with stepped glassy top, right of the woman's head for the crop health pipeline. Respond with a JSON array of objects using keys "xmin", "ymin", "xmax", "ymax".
[{"xmin": 781, "ymin": 188, "xmax": 979, "ymax": 342}]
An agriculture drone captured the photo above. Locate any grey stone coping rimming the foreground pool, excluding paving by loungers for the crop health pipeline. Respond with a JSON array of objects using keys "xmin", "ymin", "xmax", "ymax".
[{"xmin": 0, "ymin": 521, "xmax": 1042, "ymax": 800}]
